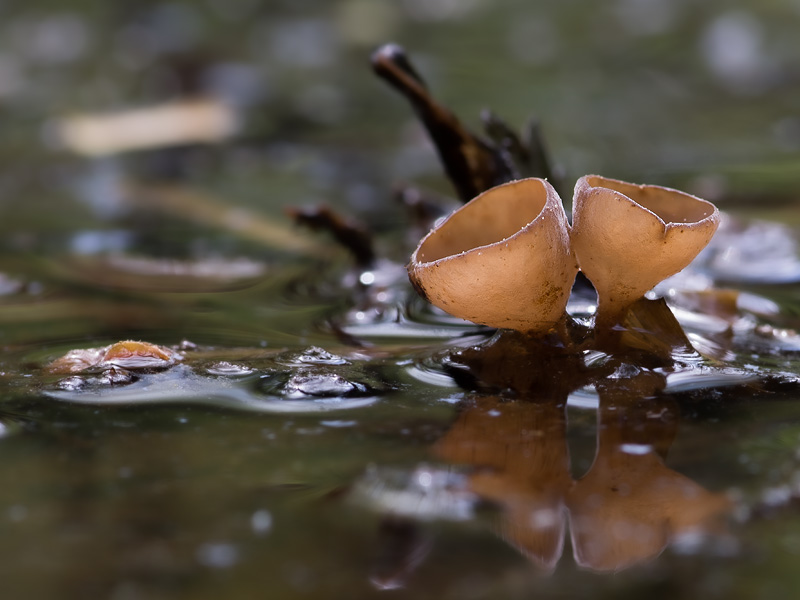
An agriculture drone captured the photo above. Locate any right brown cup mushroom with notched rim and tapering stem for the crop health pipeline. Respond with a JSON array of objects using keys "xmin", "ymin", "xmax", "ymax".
[{"xmin": 572, "ymin": 175, "xmax": 719, "ymax": 336}]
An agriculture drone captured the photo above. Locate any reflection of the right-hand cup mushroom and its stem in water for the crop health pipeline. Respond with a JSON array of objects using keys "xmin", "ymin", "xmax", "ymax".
[{"xmin": 567, "ymin": 371, "xmax": 731, "ymax": 571}]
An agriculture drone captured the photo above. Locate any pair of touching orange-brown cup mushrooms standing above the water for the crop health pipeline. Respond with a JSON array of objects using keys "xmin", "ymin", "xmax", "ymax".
[{"xmin": 408, "ymin": 175, "xmax": 719, "ymax": 346}]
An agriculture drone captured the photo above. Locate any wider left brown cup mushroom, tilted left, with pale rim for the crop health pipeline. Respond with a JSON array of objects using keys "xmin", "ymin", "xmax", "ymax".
[{"xmin": 408, "ymin": 178, "xmax": 577, "ymax": 335}]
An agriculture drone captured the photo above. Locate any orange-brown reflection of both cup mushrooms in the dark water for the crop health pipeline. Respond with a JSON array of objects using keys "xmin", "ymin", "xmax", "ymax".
[{"xmin": 434, "ymin": 371, "xmax": 730, "ymax": 571}]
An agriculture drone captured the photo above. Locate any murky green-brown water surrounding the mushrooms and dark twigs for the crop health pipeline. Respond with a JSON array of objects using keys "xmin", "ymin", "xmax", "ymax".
[{"xmin": 0, "ymin": 0, "xmax": 800, "ymax": 600}]
